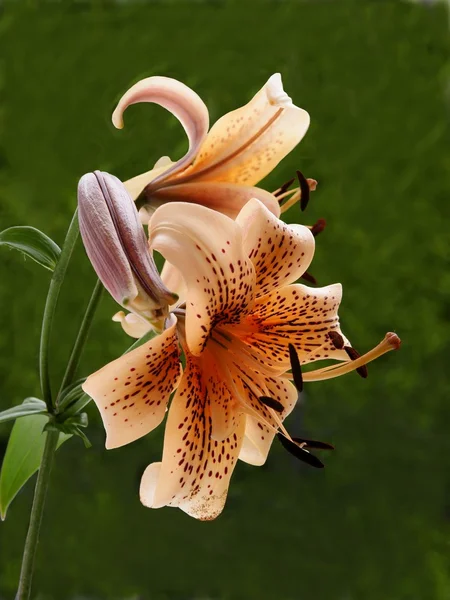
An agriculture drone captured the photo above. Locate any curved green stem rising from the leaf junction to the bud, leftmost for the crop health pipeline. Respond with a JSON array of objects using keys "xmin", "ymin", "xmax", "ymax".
[{"xmin": 39, "ymin": 211, "xmax": 78, "ymax": 413}]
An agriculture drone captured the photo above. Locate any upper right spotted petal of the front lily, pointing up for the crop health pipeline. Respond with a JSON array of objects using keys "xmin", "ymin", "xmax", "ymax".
[{"xmin": 236, "ymin": 200, "xmax": 315, "ymax": 296}]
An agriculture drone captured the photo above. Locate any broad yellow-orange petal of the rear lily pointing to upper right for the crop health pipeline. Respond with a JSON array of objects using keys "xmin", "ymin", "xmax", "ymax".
[{"xmin": 180, "ymin": 73, "xmax": 310, "ymax": 185}]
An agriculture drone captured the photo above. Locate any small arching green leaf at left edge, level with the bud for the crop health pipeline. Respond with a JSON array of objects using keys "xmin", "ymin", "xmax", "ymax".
[{"xmin": 0, "ymin": 226, "xmax": 61, "ymax": 271}]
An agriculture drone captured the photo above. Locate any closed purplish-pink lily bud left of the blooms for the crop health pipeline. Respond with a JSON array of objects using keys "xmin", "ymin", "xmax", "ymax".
[{"xmin": 78, "ymin": 171, "xmax": 176, "ymax": 329}]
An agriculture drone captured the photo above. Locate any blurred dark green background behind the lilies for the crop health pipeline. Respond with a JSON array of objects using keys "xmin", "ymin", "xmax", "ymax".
[{"xmin": 0, "ymin": 0, "xmax": 450, "ymax": 600}]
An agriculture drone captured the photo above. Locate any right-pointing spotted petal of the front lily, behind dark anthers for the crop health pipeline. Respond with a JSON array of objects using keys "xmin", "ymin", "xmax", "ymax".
[{"xmin": 244, "ymin": 283, "xmax": 350, "ymax": 369}]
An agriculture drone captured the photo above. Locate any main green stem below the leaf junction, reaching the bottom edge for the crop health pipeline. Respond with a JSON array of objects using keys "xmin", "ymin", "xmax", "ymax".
[{"xmin": 16, "ymin": 431, "xmax": 59, "ymax": 600}]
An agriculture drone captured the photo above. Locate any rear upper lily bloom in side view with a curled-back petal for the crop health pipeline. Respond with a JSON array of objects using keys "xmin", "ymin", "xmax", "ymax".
[{"xmin": 112, "ymin": 73, "xmax": 316, "ymax": 221}]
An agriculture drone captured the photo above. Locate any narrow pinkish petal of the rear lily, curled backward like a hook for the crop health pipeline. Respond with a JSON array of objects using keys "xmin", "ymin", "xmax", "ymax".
[{"xmin": 112, "ymin": 77, "xmax": 209, "ymax": 184}]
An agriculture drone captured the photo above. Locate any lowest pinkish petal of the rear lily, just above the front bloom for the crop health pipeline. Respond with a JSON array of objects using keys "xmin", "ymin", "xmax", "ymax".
[{"xmin": 152, "ymin": 181, "xmax": 280, "ymax": 219}]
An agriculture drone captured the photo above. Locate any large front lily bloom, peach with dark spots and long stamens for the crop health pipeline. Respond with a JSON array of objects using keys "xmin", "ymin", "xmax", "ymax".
[{"xmin": 83, "ymin": 199, "xmax": 398, "ymax": 520}]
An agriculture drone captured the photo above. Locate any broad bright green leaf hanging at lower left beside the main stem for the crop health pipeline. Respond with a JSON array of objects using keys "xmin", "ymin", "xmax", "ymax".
[{"xmin": 0, "ymin": 415, "xmax": 71, "ymax": 521}]
